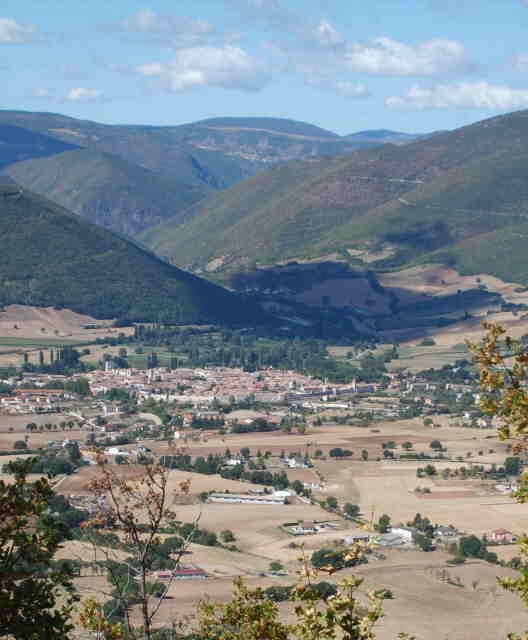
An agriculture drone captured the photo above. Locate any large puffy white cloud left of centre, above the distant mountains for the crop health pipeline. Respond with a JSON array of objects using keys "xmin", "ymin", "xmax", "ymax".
[{"xmin": 135, "ymin": 45, "xmax": 268, "ymax": 91}]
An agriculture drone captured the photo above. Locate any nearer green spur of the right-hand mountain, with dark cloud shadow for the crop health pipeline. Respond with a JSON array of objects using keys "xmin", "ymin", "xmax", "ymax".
[{"xmin": 319, "ymin": 148, "xmax": 528, "ymax": 264}]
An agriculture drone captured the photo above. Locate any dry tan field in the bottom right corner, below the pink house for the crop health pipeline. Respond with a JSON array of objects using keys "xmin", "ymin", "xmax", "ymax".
[{"xmin": 357, "ymin": 551, "xmax": 526, "ymax": 640}]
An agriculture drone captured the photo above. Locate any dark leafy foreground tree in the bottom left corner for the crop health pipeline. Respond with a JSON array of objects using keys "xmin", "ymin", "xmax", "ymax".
[{"xmin": 0, "ymin": 460, "xmax": 77, "ymax": 640}]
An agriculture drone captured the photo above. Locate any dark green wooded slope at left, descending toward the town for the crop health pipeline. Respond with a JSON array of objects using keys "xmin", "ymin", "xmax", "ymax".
[{"xmin": 0, "ymin": 185, "xmax": 272, "ymax": 324}]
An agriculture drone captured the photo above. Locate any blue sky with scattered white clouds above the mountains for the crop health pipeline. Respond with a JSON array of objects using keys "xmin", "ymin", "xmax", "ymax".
[{"xmin": 0, "ymin": 0, "xmax": 528, "ymax": 135}]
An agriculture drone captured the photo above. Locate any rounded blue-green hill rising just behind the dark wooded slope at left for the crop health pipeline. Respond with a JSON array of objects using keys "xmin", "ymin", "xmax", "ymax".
[{"xmin": 4, "ymin": 149, "xmax": 206, "ymax": 236}]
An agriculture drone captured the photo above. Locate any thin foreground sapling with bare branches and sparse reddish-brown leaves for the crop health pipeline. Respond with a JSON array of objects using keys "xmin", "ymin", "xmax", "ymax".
[{"xmin": 81, "ymin": 455, "xmax": 199, "ymax": 640}]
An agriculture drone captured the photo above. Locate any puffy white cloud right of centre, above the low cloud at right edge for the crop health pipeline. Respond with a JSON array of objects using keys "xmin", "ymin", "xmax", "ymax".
[{"xmin": 345, "ymin": 37, "xmax": 468, "ymax": 76}]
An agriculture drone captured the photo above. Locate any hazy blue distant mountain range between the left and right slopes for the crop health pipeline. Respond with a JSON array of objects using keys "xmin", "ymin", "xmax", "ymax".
[{"xmin": 0, "ymin": 111, "xmax": 428, "ymax": 236}]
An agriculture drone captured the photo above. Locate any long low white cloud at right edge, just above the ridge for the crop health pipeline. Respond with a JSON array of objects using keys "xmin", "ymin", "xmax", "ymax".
[{"xmin": 385, "ymin": 82, "xmax": 528, "ymax": 110}]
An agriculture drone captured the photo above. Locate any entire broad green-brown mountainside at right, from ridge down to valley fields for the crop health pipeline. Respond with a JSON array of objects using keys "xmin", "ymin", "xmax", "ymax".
[{"xmin": 144, "ymin": 112, "xmax": 528, "ymax": 278}]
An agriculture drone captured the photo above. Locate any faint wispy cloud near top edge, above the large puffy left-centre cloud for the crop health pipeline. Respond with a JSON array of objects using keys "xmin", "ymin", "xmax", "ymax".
[{"xmin": 101, "ymin": 9, "xmax": 215, "ymax": 47}]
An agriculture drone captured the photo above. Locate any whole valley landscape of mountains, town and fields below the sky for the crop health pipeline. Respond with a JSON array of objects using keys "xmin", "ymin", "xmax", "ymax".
[{"xmin": 0, "ymin": 106, "xmax": 528, "ymax": 640}]
